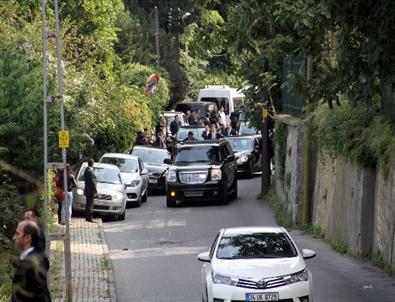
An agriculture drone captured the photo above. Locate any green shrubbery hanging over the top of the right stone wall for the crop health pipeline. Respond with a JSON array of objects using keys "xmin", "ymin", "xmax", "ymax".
[{"xmin": 312, "ymin": 100, "xmax": 395, "ymax": 173}]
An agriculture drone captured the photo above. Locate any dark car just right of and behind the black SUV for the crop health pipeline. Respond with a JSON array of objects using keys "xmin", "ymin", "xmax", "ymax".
[{"xmin": 225, "ymin": 135, "xmax": 262, "ymax": 177}]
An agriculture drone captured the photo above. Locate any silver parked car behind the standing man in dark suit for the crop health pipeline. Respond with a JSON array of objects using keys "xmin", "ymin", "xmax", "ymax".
[{"xmin": 73, "ymin": 162, "xmax": 127, "ymax": 220}]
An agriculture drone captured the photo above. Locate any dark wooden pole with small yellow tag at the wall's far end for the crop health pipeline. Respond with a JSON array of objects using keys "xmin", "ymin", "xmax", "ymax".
[{"xmin": 261, "ymin": 101, "xmax": 271, "ymax": 197}]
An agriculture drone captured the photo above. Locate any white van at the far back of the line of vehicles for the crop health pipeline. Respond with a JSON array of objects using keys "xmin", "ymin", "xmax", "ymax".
[{"xmin": 198, "ymin": 85, "xmax": 245, "ymax": 120}]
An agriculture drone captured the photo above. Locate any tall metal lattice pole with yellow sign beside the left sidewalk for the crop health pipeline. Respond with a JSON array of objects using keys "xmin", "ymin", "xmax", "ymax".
[{"xmin": 42, "ymin": 0, "xmax": 73, "ymax": 302}]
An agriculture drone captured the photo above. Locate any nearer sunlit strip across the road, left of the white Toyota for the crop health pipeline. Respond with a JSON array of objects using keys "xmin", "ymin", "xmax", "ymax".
[{"xmin": 109, "ymin": 246, "xmax": 207, "ymax": 260}]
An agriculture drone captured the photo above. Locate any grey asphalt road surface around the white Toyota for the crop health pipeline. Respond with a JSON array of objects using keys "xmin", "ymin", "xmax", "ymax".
[{"xmin": 104, "ymin": 177, "xmax": 395, "ymax": 302}]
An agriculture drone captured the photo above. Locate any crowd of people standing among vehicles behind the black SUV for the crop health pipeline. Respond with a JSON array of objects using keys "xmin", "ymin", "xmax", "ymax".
[{"xmin": 134, "ymin": 106, "xmax": 241, "ymax": 149}]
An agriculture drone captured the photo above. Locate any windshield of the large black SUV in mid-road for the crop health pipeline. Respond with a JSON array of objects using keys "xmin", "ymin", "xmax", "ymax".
[{"xmin": 174, "ymin": 145, "xmax": 220, "ymax": 164}]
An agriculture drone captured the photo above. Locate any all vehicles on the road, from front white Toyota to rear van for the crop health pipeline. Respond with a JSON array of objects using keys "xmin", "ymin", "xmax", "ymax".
[{"xmin": 73, "ymin": 86, "xmax": 315, "ymax": 302}]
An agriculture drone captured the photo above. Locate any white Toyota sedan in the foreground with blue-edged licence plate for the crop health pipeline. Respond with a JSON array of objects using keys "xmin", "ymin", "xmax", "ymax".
[{"xmin": 197, "ymin": 227, "xmax": 315, "ymax": 302}]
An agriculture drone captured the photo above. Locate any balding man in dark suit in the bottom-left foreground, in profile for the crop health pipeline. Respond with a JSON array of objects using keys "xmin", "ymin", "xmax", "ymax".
[{"xmin": 11, "ymin": 220, "xmax": 51, "ymax": 302}]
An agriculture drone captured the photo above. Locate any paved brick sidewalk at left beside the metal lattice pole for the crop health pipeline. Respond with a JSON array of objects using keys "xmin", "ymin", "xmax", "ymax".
[{"xmin": 49, "ymin": 218, "xmax": 116, "ymax": 302}]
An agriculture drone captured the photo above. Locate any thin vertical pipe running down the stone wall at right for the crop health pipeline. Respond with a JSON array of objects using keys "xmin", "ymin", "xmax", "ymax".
[{"xmin": 302, "ymin": 56, "xmax": 313, "ymax": 224}]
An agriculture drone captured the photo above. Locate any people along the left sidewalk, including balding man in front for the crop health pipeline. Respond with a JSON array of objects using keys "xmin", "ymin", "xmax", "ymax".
[{"xmin": 11, "ymin": 159, "xmax": 98, "ymax": 302}]
